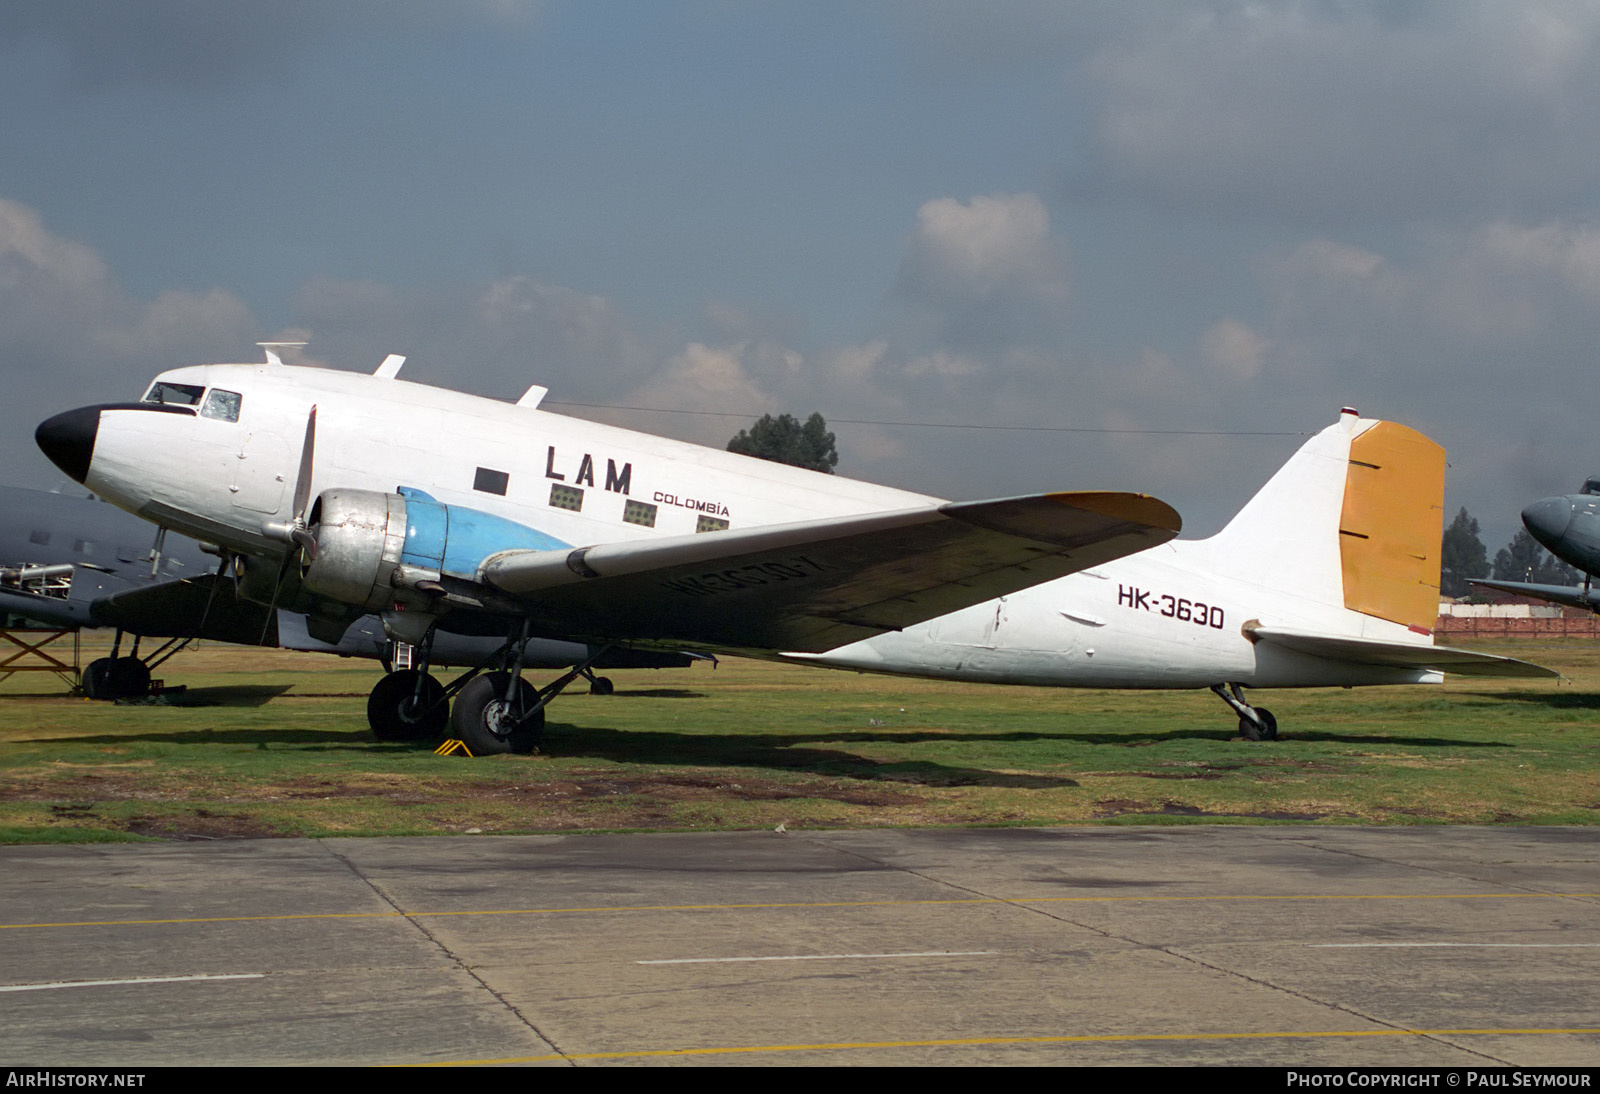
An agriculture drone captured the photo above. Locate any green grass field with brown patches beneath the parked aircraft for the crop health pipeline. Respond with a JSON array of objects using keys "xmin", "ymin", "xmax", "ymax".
[{"xmin": 0, "ymin": 626, "xmax": 1600, "ymax": 843}]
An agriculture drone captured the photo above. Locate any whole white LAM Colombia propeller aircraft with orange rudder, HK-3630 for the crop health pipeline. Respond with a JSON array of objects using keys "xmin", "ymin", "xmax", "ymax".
[{"xmin": 37, "ymin": 345, "xmax": 1544, "ymax": 753}]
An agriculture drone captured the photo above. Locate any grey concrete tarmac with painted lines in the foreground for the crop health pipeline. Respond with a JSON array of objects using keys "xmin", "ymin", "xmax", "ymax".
[{"xmin": 0, "ymin": 827, "xmax": 1600, "ymax": 1068}]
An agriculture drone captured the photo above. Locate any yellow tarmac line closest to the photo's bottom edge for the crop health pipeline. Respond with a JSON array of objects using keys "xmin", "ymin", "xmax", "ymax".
[{"xmin": 403, "ymin": 1027, "xmax": 1600, "ymax": 1067}]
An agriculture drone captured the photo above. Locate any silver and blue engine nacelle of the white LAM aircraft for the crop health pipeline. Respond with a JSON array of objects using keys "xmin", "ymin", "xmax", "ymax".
[{"xmin": 302, "ymin": 488, "xmax": 568, "ymax": 611}]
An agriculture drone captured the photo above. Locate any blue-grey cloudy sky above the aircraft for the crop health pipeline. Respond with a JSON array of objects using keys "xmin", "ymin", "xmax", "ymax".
[{"xmin": 0, "ymin": 0, "xmax": 1600, "ymax": 552}]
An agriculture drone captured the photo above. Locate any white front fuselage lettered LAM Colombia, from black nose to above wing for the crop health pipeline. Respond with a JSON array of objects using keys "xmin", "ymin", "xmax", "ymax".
[{"xmin": 40, "ymin": 365, "xmax": 934, "ymax": 557}]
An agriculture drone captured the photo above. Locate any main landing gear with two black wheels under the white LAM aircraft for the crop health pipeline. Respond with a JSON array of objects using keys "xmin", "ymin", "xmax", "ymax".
[{"xmin": 366, "ymin": 624, "xmax": 611, "ymax": 757}]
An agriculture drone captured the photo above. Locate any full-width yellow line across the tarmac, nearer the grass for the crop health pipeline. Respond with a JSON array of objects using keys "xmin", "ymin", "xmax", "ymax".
[{"xmin": 0, "ymin": 892, "xmax": 1600, "ymax": 931}]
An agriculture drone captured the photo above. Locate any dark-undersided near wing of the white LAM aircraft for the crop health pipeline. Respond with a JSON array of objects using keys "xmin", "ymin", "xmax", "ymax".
[{"xmin": 478, "ymin": 491, "xmax": 1182, "ymax": 653}]
